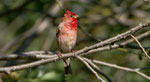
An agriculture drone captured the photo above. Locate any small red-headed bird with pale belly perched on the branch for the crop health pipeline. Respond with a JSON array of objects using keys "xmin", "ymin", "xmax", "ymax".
[{"xmin": 56, "ymin": 10, "xmax": 78, "ymax": 75}]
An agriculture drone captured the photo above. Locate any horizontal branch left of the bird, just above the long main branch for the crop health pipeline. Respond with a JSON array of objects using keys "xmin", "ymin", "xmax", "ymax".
[{"xmin": 0, "ymin": 51, "xmax": 54, "ymax": 60}]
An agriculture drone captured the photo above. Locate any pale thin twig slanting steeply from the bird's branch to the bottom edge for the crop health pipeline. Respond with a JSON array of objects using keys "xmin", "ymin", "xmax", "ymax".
[{"xmin": 76, "ymin": 56, "xmax": 106, "ymax": 82}]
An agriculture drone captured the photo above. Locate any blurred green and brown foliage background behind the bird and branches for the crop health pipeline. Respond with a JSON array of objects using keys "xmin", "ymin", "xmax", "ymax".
[{"xmin": 0, "ymin": 0, "xmax": 150, "ymax": 82}]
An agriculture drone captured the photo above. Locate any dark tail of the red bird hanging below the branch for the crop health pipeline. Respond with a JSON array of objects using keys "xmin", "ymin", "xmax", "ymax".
[{"xmin": 63, "ymin": 58, "xmax": 72, "ymax": 75}]
